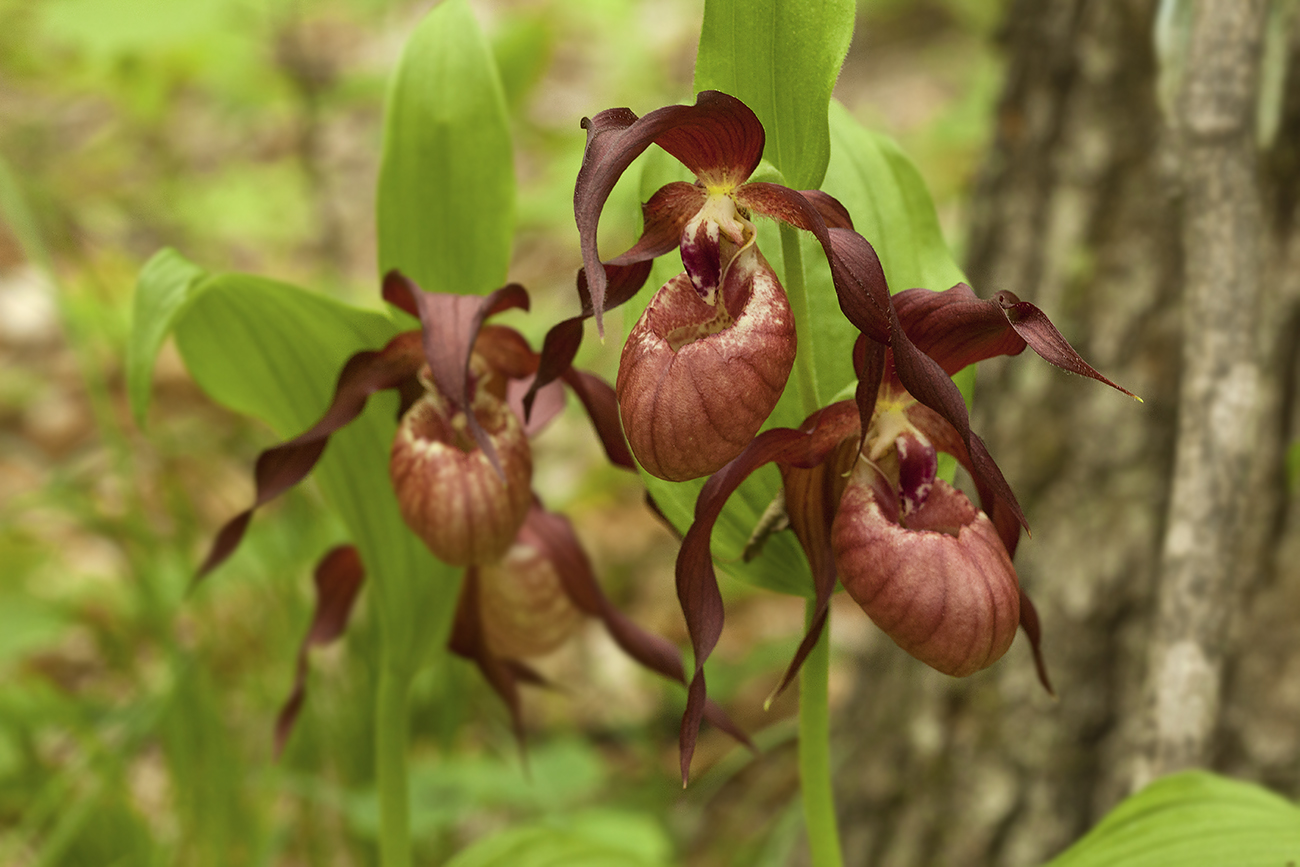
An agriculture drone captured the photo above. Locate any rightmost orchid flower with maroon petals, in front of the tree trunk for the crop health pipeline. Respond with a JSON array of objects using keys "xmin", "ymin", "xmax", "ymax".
[{"xmin": 677, "ymin": 279, "xmax": 1134, "ymax": 779}]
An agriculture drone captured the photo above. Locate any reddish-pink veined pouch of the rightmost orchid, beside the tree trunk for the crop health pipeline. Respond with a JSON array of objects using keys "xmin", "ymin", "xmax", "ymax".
[{"xmin": 832, "ymin": 460, "xmax": 1021, "ymax": 677}]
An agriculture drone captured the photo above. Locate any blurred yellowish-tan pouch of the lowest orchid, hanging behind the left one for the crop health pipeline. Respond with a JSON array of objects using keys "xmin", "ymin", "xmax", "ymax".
[{"xmin": 478, "ymin": 545, "xmax": 582, "ymax": 659}]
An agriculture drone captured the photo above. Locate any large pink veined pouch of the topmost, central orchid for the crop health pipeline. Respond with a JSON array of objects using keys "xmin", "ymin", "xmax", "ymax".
[{"xmin": 618, "ymin": 243, "xmax": 796, "ymax": 481}]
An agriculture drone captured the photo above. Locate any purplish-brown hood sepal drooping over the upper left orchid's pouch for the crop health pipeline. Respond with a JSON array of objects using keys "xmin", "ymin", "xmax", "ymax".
[{"xmin": 384, "ymin": 270, "xmax": 528, "ymax": 473}]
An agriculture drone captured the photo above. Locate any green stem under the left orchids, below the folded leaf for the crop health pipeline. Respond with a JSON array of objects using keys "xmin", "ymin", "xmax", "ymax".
[{"xmin": 374, "ymin": 660, "xmax": 411, "ymax": 867}]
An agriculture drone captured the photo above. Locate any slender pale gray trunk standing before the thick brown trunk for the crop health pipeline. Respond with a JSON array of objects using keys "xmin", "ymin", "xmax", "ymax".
[{"xmin": 1135, "ymin": 0, "xmax": 1269, "ymax": 786}]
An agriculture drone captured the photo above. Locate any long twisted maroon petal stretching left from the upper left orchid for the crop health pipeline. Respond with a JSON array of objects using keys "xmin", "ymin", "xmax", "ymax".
[{"xmin": 195, "ymin": 331, "xmax": 424, "ymax": 581}]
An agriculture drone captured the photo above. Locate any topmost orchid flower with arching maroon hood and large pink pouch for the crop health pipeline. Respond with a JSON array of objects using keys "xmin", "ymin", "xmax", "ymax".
[{"xmin": 522, "ymin": 91, "xmax": 850, "ymax": 481}]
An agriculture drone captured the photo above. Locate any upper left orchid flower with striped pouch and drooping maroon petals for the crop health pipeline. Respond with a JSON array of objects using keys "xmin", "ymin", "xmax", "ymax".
[{"xmin": 199, "ymin": 272, "xmax": 631, "ymax": 577}]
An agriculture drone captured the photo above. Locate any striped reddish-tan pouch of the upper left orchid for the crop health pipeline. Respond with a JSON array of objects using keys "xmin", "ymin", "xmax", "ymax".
[{"xmin": 389, "ymin": 389, "xmax": 533, "ymax": 565}]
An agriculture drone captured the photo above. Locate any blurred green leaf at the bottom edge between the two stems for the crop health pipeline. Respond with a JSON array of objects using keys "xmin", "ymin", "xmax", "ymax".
[{"xmin": 447, "ymin": 810, "xmax": 671, "ymax": 867}]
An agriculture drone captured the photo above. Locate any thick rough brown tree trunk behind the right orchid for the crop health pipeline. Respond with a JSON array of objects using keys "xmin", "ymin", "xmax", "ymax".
[{"xmin": 837, "ymin": 0, "xmax": 1300, "ymax": 867}]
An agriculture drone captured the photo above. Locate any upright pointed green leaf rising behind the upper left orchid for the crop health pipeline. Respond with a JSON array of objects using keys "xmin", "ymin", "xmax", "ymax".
[{"xmin": 377, "ymin": 0, "xmax": 515, "ymax": 294}]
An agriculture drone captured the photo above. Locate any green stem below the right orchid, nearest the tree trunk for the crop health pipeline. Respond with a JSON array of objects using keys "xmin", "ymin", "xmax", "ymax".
[{"xmin": 800, "ymin": 599, "xmax": 844, "ymax": 867}]
